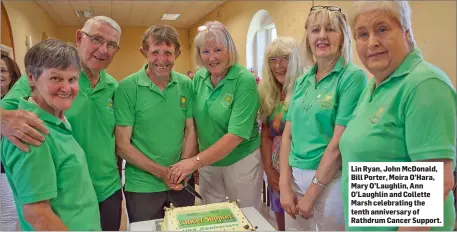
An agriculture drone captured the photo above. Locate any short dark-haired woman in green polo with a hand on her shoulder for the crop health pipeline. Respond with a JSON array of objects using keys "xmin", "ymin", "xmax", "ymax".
[{"xmin": 1, "ymin": 39, "xmax": 101, "ymax": 231}]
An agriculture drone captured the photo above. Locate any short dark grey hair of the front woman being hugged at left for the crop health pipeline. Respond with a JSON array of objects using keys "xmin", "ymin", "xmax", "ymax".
[{"xmin": 24, "ymin": 39, "xmax": 81, "ymax": 79}]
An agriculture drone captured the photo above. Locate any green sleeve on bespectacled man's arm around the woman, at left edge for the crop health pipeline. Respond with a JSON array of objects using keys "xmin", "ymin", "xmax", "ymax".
[{"xmin": 1, "ymin": 75, "xmax": 32, "ymax": 110}]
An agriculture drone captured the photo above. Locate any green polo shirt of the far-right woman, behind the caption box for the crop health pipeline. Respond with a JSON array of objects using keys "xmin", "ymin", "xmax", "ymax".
[{"xmin": 340, "ymin": 49, "xmax": 456, "ymax": 231}]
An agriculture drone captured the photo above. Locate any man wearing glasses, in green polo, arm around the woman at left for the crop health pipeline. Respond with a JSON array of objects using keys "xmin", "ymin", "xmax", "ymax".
[{"xmin": 2, "ymin": 16, "xmax": 122, "ymax": 231}]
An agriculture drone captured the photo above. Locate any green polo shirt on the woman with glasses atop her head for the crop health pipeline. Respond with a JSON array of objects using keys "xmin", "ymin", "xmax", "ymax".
[{"xmin": 286, "ymin": 57, "xmax": 367, "ymax": 170}]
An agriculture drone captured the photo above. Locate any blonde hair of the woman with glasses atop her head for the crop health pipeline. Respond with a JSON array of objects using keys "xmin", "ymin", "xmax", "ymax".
[{"xmin": 302, "ymin": 6, "xmax": 352, "ymax": 67}]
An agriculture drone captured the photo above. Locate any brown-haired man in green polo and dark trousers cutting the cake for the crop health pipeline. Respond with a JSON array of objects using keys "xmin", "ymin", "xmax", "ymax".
[{"xmin": 114, "ymin": 25, "xmax": 197, "ymax": 222}]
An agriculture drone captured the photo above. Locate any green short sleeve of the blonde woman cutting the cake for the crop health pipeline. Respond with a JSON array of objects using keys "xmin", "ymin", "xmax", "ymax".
[{"xmin": 228, "ymin": 79, "xmax": 260, "ymax": 139}]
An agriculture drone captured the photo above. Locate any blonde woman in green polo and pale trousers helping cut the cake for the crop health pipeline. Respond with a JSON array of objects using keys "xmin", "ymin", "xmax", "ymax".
[{"xmin": 170, "ymin": 22, "xmax": 263, "ymax": 209}]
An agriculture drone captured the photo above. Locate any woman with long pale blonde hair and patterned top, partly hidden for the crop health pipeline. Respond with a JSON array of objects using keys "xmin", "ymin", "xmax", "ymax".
[{"xmin": 259, "ymin": 37, "xmax": 304, "ymax": 231}]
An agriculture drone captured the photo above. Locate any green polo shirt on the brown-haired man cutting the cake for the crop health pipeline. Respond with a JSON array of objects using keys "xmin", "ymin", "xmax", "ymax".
[{"xmin": 114, "ymin": 65, "xmax": 193, "ymax": 193}]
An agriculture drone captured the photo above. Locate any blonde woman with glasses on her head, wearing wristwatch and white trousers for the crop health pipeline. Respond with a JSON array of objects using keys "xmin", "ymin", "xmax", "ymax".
[{"xmin": 279, "ymin": 6, "xmax": 367, "ymax": 231}]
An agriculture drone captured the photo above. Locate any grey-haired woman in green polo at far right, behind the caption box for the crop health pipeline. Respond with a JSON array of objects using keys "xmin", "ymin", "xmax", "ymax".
[{"xmin": 340, "ymin": 1, "xmax": 456, "ymax": 231}]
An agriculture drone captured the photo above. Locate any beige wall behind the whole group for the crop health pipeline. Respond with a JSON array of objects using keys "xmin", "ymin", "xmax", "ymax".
[{"xmin": 5, "ymin": 1, "xmax": 456, "ymax": 85}]
